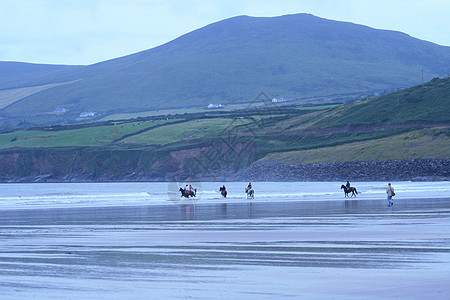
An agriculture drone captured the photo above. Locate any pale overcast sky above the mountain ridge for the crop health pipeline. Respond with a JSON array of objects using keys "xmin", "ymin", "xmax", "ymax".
[{"xmin": 0, "ymin": 0, "xmax": 450, "ymax": 65}]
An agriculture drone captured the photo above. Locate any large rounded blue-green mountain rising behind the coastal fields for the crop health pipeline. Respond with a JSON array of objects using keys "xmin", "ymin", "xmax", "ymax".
[{"xmin": 0, "ymin": 14, "xmax": 450, "ymax": 124}]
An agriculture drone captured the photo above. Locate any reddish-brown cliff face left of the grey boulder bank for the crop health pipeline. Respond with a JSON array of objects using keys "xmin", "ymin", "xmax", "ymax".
[{"xmin": 0, "ymin": 144, "xmax": 255, "ymax": 182}]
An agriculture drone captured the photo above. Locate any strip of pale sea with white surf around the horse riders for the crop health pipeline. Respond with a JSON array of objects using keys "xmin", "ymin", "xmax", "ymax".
[{"xmin": 0, "ymin": 181, "xmax": 450, "ymax": 210}]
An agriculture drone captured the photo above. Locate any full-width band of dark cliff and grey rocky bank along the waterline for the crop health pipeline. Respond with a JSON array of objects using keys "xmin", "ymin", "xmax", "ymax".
[{"xmin": 0, "ymin": 146, "xmax": 450, "ymax": 182}]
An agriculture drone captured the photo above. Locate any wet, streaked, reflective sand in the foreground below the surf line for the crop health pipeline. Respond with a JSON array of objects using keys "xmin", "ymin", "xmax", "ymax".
[{"xmin": 0, "ymin": 198, "xmax": 450, "ymax": 299}]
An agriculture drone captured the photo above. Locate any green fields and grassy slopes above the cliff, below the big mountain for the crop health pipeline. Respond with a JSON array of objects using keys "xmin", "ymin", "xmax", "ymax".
[{"xmin": 0, "ymin": 78, "xmax": 450, "ymax": 168}]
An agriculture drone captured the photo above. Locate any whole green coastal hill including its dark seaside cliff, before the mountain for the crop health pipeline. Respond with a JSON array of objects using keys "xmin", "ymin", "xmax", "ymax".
[{"xmin": 0, "ymin": 78, "xmax": 450, "ymax": 180}]
